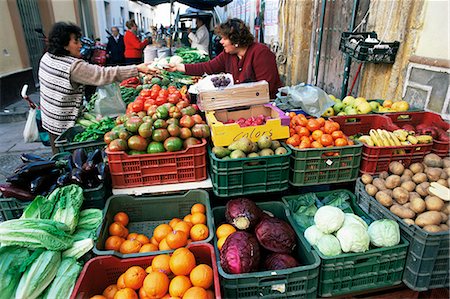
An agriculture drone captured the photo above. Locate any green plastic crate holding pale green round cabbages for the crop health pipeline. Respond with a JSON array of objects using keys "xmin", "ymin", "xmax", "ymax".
[{"xmin": 283, "ymin": 190, "xmax": 409, "ymax": 297}]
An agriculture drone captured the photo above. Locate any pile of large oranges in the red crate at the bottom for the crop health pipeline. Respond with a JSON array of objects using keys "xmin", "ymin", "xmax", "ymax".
[{"xmin": 91, "ymin": 248, "xmax": 215, "ymax": 299}]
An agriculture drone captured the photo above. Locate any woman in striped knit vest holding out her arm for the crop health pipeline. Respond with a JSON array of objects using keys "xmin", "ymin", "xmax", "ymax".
[{"xmin": 39, "ymin": 22, "xmax": 156, "ymax": 154}]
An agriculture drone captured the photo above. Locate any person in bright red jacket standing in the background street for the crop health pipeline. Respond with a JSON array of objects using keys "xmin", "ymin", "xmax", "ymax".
[{"xmin": 123, "ymin": 19, "xmax": 149, "ymax": 65}]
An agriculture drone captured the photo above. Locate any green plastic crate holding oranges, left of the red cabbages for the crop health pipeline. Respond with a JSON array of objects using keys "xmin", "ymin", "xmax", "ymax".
[{"xmin": 94, "ymin": 190, "xmax": 214, "ymax": 258}]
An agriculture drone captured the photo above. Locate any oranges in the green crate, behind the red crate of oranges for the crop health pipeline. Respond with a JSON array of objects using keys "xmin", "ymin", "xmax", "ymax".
[{"xmin": 105, "ymin": 203, "xmax": 209, "ymax": 254}]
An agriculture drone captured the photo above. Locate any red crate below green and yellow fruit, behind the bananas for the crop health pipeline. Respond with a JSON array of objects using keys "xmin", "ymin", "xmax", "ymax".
[{"xmin": 330, "ymin": 114, "xmax": 394, "ymax": 136}]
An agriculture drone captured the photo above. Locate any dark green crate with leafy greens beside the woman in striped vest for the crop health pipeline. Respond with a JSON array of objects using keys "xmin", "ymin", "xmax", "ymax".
[{"xmin": 55, "ymin": 126, "xmax": 106, "ymax": 153}]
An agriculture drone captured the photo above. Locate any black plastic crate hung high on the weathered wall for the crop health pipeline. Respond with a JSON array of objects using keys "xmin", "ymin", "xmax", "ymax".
[{"xmin": 339, "ymin": 32, "xmax": 400, "ymax": 63}]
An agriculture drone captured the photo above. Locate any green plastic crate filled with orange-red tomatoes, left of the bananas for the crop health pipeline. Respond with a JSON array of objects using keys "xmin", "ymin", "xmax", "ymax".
[{"xmin": 289, "ymin": 141, "xmax": 363, "ymax": 187}]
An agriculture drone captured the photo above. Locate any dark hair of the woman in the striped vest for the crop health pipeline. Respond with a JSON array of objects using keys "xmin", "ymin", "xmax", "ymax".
[{"xmin": 47, "ymin": 22, "xmax": 81, "ymax": 56}]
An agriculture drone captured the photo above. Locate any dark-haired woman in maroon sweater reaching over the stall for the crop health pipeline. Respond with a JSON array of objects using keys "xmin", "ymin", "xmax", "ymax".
[{"xmin": 168, "ymin": 19, "xmax": 282, "ymax": 99}]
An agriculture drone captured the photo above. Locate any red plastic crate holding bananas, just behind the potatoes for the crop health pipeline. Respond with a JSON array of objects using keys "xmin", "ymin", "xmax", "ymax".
[{"xmin": 360, "ymin": 143, "xmax": 433, "ymax": 174}]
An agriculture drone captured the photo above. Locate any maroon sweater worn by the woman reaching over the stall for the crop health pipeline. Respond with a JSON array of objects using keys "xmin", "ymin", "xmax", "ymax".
[{"xmin": 185, "ymin": 43, "xmax": 282, "ymax": 99}]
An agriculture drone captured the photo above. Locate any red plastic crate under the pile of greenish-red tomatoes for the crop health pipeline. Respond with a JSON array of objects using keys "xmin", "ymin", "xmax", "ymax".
[{"xmin": 106, "ymin": 139, "xmax": 207, "ymax": 188}]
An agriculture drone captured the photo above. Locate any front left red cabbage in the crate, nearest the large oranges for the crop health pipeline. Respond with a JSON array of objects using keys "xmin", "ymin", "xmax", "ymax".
[{"xmin": 220, "ymin": 231, "xmax": 260, "ymax": 274}]
